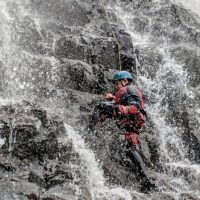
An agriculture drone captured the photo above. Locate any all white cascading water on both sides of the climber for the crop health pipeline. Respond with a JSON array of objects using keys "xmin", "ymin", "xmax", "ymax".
[{"xmin": 0, "ymin": 0, "xmax": 200, "ymax": 200}]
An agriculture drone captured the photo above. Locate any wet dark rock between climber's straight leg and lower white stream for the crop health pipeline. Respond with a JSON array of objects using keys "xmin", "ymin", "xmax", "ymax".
[{"xmin": 81, "ymin": 119, "xmax": 155, "ymax": 190}]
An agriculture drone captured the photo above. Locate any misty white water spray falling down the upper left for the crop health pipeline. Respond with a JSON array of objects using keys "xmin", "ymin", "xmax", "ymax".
[{"xmin": 0, "ymin": 0, "xmax": 59, "ymax": 101}]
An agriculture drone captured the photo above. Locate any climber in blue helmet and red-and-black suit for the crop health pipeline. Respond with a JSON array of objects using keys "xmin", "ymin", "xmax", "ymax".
[{"xmin": 88, "ymin": 71, "xmax": 157, "ymax": 193}]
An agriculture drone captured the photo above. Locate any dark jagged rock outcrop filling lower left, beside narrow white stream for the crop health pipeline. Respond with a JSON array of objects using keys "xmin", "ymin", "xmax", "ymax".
[{"xmin": 0, "ymin": 102, "xmax": 90, "ymax": 200}]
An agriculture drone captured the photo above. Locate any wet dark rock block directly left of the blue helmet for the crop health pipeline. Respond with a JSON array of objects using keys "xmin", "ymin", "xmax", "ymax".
[{"xmin": 54, "ymin": 60, "xmax": 111, "ymax": 94}]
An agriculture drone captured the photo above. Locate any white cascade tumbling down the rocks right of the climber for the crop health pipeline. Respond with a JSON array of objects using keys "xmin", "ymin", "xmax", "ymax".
[{"xmin": 110, "ymin": 1, "xmax": 200, "ymax": 199}]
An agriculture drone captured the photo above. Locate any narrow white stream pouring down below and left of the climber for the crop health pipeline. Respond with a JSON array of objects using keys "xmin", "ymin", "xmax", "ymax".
[{"xmin": 65, "ymin": 124, "xmax": 132, "ymax": 200}]
